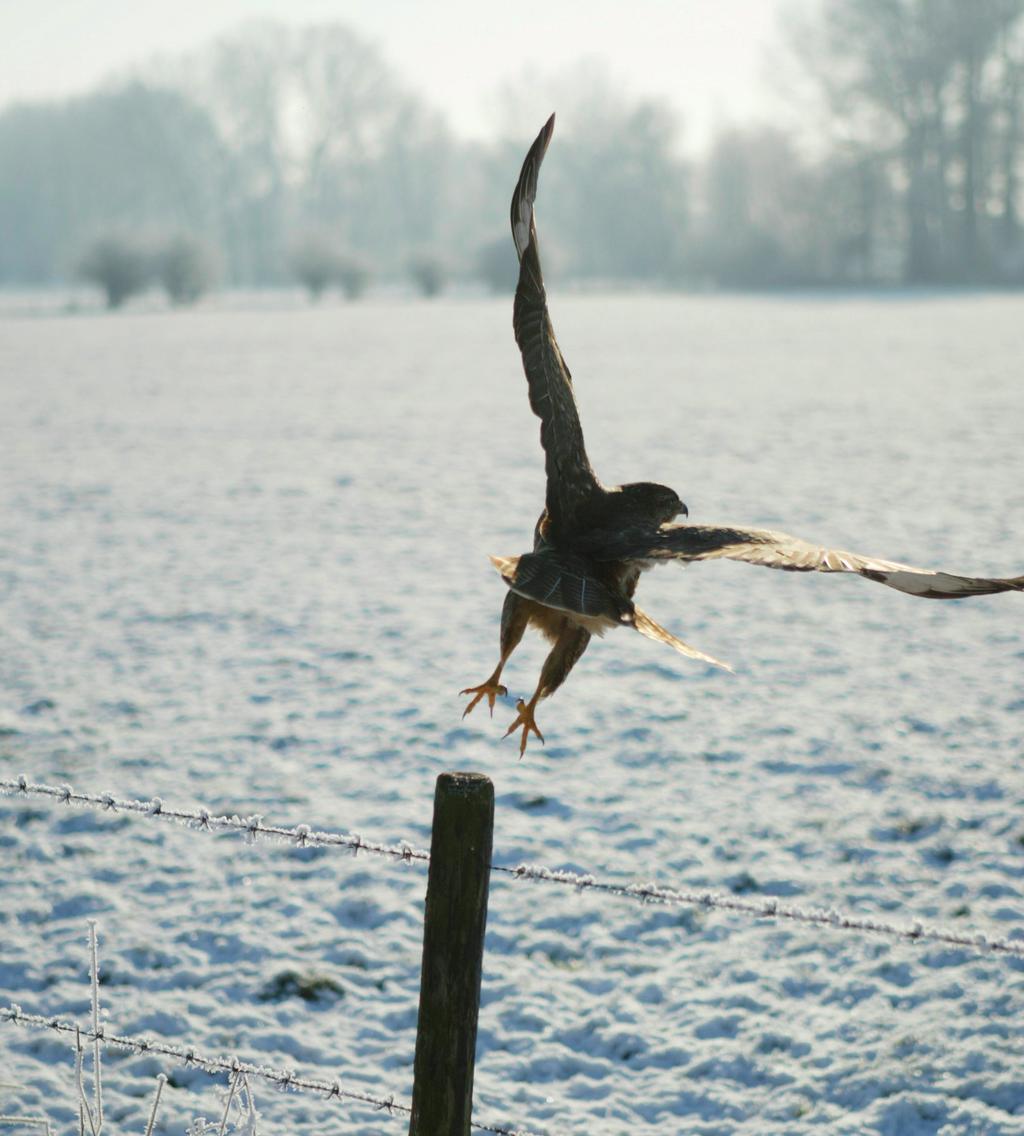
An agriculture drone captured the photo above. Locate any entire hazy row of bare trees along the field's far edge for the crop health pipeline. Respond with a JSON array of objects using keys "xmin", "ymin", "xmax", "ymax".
[{"xmin": 0, "ymin": 0, "xmax": 1024, "ymax": 294}]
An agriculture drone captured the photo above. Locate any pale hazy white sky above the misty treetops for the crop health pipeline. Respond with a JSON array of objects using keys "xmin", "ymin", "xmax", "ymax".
[{"xmin": 0, "ymin": 0, "xmax": 784, "ymax": 145}]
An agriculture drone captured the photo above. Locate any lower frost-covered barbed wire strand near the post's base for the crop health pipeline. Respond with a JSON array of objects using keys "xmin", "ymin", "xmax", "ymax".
[{"xmin": 0, "ymin": 1002, "xmax": 535, "ymax": 1136}]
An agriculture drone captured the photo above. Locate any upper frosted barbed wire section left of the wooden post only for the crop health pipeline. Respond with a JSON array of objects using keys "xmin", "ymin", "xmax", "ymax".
[{"xmin": 0, "ymin": 776, "xmax": 431, "ymax": 863}]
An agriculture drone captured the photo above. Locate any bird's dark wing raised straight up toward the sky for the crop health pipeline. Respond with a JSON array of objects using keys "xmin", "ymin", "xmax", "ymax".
[{"xmin": 511, "ymin": 115, "xmax": 599, "ymax": 527}]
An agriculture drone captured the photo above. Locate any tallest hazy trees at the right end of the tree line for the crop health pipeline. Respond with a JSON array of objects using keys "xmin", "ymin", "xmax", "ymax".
[{"xmin": 791, "ymin": 0, "xmax": 1024, "ymax": 282}]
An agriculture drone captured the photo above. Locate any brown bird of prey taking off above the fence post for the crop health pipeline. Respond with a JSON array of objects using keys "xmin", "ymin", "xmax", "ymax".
[{"xmin": 461, "ymin": 115, "xmax": 1024, "ymax": 758}]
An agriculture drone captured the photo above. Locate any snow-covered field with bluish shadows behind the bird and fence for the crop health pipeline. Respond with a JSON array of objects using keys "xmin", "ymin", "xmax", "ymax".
[{"xmin": 0, "ymin": 295, "xmax": 1024, "ymax": 1136}]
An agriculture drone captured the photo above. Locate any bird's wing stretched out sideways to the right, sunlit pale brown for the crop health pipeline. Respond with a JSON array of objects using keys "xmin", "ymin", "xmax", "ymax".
[{"xmin": 631, "ymin": 525, "xmax": 1024, "ymax": 600}]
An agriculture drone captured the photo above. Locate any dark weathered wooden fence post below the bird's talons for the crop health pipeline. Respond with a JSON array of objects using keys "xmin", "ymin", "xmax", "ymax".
[{"xmin": 409, "ymin": 774, "xmax": 494, "ymax": 1136}]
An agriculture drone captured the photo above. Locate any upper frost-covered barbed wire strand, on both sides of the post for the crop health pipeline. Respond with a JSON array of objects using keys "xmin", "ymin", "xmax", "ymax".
[{"xmin": 0, "ymin": 776, "xmax": 1024, "ymax": 959}]
